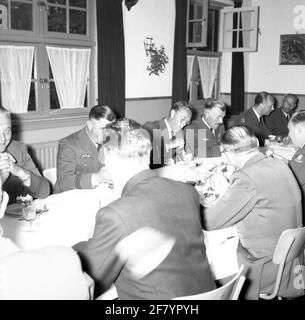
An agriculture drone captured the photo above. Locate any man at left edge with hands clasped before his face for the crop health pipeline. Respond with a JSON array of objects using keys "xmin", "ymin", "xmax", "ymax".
[{"xmin": 0, "ymin": 106, "xmax": 50, "ymax": 203}]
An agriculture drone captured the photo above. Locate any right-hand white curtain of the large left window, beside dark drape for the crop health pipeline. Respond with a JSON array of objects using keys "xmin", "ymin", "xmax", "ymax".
[{"xmin": 47, "ymin": 46, "xmax": 91, "ymax": 109}]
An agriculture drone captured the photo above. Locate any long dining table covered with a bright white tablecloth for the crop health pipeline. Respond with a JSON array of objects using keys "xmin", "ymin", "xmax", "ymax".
[{"xmin": 0, "ymin": 157, "xmax": 239, "ymax": 279}]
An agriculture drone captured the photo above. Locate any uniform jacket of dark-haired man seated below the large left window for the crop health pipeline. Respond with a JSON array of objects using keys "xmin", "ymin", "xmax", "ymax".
[{"xmin": 54, "ymin": 127, "xmax": 103, "ymax": 193}]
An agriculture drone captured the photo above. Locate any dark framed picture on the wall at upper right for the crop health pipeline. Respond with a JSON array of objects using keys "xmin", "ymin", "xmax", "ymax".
[{"xmin": 280, "ymin": 34, "xmax": 305, "ymax": 65}]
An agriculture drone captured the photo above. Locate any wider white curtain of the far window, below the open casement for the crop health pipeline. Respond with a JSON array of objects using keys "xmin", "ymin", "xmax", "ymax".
[{"xmin": 198, "ymin": 57, "xmax": 219, "ymax": 99}]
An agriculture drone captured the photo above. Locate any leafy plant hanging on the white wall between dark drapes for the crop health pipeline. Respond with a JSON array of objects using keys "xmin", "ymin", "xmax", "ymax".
[{"xmin": 144, "ymin": 37, "xmax": 169, "ymax": 76}]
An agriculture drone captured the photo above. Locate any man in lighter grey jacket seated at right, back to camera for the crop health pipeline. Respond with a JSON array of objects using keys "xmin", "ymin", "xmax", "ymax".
[{"xmin": 203, "ymin": 126, "xmax": 304, "ymax": 299}]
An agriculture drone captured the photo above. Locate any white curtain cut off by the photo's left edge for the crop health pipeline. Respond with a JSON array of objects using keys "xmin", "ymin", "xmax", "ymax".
[{"xmin": 0, "ymin": 46, "xmax": 34, "ymax": 113}]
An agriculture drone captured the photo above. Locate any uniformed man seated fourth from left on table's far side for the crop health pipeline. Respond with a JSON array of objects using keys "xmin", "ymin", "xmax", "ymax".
[{"xmin": 184, "ymin": 99, "xmax": 226, "ymax": 158}]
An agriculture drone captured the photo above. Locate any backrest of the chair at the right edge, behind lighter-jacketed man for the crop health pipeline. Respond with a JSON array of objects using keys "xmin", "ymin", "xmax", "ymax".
[{"xmin": 273, "ymin": 227, "xmax": 305, "ymax": 264}]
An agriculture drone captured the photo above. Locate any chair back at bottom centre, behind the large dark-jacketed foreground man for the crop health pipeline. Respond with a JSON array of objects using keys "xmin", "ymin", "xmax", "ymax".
[{"xmin": 173, "ymin": 265, "xmax": 246, "ymax": 300}]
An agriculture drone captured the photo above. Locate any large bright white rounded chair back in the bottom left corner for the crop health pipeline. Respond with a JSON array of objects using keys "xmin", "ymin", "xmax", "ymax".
[{"xmin": 0, "ymin": 246, "xmax": 94, "ymax": 300}]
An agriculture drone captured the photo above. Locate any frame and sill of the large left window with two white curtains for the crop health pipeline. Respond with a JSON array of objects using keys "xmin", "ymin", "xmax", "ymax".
[{"xmin": 0, "ymin": 0, "xmax": 97, "ymax": 131}]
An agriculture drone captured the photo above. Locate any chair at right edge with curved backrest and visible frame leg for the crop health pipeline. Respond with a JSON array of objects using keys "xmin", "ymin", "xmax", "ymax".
[{"xmin": 259, "ymin": 227, "xmax": 305, "ymax": 300}]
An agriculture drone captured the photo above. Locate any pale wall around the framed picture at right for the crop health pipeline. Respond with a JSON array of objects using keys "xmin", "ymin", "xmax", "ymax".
[{"xmin": 221, "ymin": 0, "xmax": 305, "ymax": 108}]
